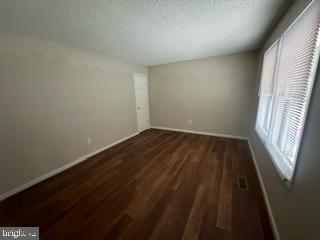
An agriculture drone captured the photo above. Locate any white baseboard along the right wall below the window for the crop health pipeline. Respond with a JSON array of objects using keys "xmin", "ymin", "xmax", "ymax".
[{"xmin": 247, "ymin": 138, "xmax": 280, "ymax": 240}]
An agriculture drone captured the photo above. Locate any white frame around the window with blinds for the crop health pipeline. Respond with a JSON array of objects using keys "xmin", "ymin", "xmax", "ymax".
[{"xmin": 255, "ymin": 0, "xmax": 320, "ymax": 188}]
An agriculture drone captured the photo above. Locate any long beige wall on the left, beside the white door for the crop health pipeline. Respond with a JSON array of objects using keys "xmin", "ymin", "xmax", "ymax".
[{"xmin": 0, "ymin": 32, "xmax": 147, "ymax": 194}]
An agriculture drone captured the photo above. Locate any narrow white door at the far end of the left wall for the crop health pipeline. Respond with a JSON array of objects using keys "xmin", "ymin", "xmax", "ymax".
[{"xmin": 133, "ymin": 73, "xmax": 150, "ymax": 132}]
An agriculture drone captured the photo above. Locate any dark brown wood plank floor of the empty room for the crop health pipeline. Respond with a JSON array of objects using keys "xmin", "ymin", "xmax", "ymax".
[{"xmin": 0, "ymin": 129, "xmax": 273, "ymax": 240}]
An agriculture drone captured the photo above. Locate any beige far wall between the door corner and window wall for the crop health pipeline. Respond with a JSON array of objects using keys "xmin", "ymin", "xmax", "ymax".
[{"xmin": 148, "ymin": 52, "xmax": 258, "ymax": 136}]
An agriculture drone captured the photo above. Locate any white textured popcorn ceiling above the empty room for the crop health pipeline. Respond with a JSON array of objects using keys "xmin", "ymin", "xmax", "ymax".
[{"xmin": 0, "ymin": 0, "xmax": 290, "ymax": 65}]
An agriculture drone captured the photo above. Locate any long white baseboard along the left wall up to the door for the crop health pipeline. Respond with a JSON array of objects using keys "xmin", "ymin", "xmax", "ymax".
[{"xmin": 0, "ymin": 133, "xmax": 138, "ymax": 201}]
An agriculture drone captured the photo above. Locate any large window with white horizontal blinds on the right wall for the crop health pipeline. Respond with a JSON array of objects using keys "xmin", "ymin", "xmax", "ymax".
[{"xmin": 256, "ymin": 1, "xmax": 320, "ymax": 182}]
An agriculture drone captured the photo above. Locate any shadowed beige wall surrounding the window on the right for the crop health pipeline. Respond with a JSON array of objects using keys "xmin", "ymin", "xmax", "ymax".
[{"xmin": 250, "ymin": 0, "xmax": 320, "ymax": 240}]
